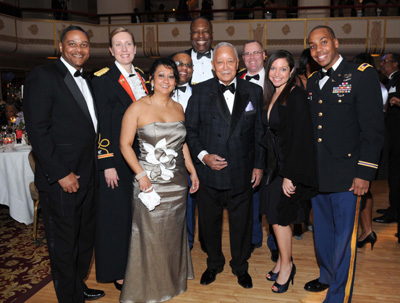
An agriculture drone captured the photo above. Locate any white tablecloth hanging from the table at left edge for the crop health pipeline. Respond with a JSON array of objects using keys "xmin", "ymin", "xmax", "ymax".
[{"xmin": 0, "ymin": 145, "xmax": 33, "ymax": 225}]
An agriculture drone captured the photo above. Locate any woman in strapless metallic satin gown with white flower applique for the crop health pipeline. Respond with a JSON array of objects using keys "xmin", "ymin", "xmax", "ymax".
[{"xmin": 120, "ymin": 58, "xmax": 199, "ymax": 303}]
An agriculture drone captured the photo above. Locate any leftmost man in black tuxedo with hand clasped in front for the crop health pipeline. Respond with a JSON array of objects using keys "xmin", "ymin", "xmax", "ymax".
[{"xmin": 24, "ymin": 26, "xmax": 104, "ymax": 303}]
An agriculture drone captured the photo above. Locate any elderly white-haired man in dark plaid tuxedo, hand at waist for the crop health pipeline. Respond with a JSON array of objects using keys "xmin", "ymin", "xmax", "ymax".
[{"xmin": 186, "ymin": 42, "xmax": 264, "ymax": 288}]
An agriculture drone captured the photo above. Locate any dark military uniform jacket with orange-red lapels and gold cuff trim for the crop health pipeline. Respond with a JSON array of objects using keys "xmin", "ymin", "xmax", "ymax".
[{"xmin": 92, "ymin": 63, "xmax": 147, "ymax": 172}]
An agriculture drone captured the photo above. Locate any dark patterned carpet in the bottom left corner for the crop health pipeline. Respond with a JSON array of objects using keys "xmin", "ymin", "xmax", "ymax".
[{"xmin": 0, "ymin": 205, "xmax": 51, "ymax": 303}]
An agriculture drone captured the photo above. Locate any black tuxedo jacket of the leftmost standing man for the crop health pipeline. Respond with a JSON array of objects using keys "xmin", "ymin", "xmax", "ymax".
[{"xmin": 24, "ymin": 59, "xmax": 97, "ymax": 192}]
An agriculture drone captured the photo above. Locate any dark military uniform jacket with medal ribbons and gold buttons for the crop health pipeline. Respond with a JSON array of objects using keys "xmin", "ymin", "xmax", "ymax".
[{"xmin": 307, "ymin": 59, "xmax": 384, "ymax": 192}]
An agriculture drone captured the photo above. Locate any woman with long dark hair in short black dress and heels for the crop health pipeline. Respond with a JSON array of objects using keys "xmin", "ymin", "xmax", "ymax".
[{"xmin": 260, "ymin": 50, "xmax": 317, "ymax": 293}]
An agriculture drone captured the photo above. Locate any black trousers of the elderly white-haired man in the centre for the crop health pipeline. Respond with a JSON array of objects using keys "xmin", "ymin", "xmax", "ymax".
[{"xmin": 197, "ymin": 184, "xmax": 253, "ymax": 271}]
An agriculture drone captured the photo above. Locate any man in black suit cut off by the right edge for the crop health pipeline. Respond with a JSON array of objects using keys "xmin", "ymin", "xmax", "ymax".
[{"xmin": 374, "ymin": 53, "xmax": 400, "ymax": 227}]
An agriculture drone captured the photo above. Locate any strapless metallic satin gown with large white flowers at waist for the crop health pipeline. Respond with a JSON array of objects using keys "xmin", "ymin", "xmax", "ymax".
[{"xmin": 120, "ymin": 121, "xmax": 194, "ymax": 303}]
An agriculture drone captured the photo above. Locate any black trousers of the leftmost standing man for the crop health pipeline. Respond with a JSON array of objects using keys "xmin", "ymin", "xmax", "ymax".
[{"xmin": 39, "ymin": 186, "xmax": 97, "ymax": 303}]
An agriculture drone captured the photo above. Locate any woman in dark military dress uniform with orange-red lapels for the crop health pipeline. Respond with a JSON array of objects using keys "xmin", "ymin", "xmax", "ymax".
[{"xmin": 93, "ymin": 27, "xmax": 147, "ymax": 289}]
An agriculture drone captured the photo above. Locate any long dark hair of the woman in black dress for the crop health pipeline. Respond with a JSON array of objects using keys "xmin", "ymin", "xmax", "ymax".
[{"xmin": 264, "ymin": 50, "xmax": 296, "ymax": 111}]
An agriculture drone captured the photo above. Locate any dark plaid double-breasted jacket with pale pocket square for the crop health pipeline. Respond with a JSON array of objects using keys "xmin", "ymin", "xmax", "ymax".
[{"xmin": 185, "ymin": 77, "xmax": 265, "ymax": 193}]
